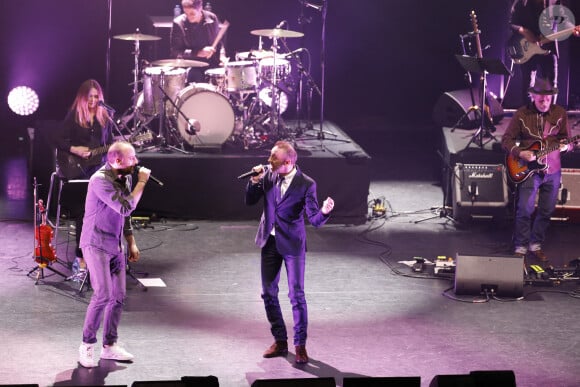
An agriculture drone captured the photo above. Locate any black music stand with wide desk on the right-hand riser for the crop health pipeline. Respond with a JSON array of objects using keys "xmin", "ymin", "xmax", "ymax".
[{"xmin": 455, "ymin": 55, "xmax": 511, "ymax": 149}]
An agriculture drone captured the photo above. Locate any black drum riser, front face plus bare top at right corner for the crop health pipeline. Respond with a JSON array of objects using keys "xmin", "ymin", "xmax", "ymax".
[{"xmin": 135, "ymin": 121, "xmax": 371, "ymax": 224}]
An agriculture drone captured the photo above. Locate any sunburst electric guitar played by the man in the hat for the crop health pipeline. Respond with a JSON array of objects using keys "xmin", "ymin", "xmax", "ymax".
[{"xmin": 505, "ymin": 134, "xmax": 580, "ymax": 184}]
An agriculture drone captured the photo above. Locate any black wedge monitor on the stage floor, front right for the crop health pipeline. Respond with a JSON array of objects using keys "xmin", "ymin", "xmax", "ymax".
[{"xmin": 454, "ymin": 254, "xmax": 524, "ymax": 297}]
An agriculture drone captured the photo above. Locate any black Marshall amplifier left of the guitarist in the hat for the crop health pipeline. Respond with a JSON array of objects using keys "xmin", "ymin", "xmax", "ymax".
[{"xmin": 451, "ymin": 163, "xmax": 509, "ymax": 221}]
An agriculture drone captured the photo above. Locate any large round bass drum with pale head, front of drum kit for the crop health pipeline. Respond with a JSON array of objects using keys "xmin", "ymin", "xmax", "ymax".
[{"xmin": 175, "ymin": 83, "xmax": 235, "ymax": 148}]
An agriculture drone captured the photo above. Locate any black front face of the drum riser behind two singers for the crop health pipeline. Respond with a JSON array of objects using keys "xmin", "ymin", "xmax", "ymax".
[{"xmin": 137, "ymin": 153, "xmax": 370, "ymax": 224}]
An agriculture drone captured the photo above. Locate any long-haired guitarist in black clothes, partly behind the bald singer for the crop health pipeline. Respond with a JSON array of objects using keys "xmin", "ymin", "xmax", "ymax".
[{"xmin": 55, "ymin": 79, "xmax": 113, "ymax": 282}]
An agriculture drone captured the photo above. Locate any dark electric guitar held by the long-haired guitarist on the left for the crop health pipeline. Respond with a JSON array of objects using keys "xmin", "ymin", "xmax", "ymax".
[{"xmin": 56, "ymin": 131, "xmax": 153, "ymax": 180}]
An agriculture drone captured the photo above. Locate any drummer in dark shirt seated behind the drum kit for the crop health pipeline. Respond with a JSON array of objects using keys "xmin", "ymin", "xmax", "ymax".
[{"xmin": 171, "ymin": 0, "xmax": 227, "ymax": 83}]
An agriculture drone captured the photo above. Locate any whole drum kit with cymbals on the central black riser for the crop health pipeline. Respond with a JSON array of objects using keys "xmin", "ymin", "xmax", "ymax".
[{"xmin": 113, "ymin": 28, "xmax": 312, "ymax": 153}]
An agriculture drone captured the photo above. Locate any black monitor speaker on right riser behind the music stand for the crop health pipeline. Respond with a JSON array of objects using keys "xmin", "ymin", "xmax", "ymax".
[{"xmin": 433, "ymin": 89, "xmax": 504, "ymax": 129}]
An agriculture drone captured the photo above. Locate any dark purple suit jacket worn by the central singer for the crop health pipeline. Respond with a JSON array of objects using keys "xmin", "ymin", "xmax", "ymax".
[{"xmin": 246, "ymin": 166, "xmax": 330, "ymax": 256}]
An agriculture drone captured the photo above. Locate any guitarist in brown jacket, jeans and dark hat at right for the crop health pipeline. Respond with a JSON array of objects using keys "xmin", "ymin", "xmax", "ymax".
[{"xmin": 502, "ymin": 78, "xmax": 573, "ymax": 262}]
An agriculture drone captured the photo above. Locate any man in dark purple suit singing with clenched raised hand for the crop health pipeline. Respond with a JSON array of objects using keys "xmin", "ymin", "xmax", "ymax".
[{"xmin": 246, "ymin": 141, "xmax": 334, "ymax": 364}]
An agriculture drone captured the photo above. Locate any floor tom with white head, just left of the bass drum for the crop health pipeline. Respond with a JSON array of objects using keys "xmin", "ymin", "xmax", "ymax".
[{"xmin": 141, "ymin": 67, "xmax": 187, "ymax": 115}]
